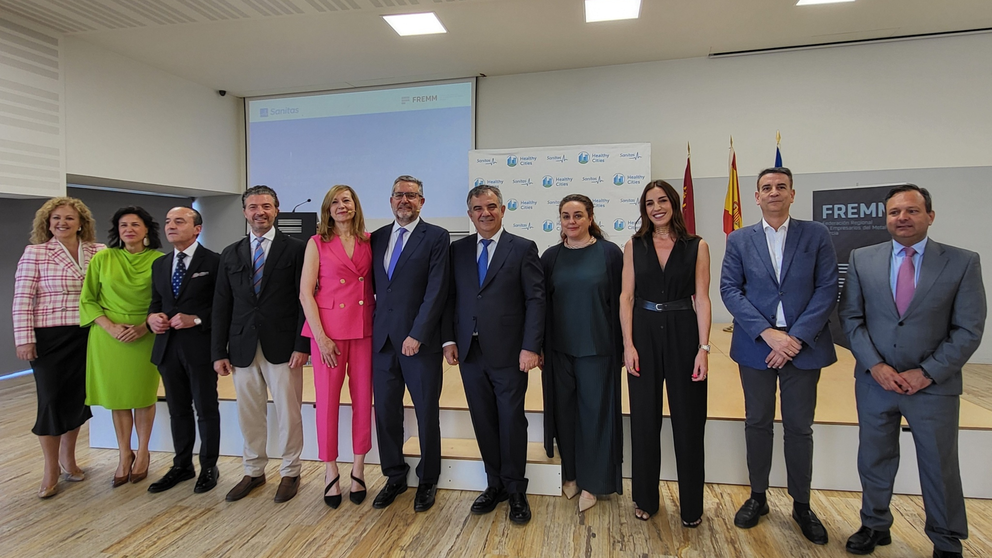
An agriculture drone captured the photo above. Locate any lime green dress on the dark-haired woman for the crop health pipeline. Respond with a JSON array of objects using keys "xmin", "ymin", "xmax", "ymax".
[{"xmin": 79, "ymin": 248, "xmax": 163, "ymax": 409}]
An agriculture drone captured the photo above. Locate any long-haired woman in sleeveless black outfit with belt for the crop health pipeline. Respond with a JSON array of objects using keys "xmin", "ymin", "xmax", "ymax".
[{"xmin": 620, "ymin": 180, "xmax": 712, "ymax": 527}]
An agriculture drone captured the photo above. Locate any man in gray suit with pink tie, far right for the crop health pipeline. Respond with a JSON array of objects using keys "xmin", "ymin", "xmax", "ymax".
[{"xmin": 840, "ymin": 184, "xmax": 986, "ymax": 558}]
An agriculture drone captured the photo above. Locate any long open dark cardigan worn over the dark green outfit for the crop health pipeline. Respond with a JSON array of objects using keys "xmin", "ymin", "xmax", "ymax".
[{"xmin": 541, "ymin": 239, "xmax": 623, "ymax": 460}]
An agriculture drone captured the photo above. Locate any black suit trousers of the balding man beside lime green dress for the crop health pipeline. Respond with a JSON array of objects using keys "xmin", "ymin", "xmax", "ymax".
[{"xmin": 158, "ymin": 343, "xmax": 220, "ymax": 469}]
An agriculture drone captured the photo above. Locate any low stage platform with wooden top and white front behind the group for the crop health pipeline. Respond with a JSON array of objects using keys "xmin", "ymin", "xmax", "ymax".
[{"xmin": 90, "ymin": 324, "xmax": 992, "ymax": 498}]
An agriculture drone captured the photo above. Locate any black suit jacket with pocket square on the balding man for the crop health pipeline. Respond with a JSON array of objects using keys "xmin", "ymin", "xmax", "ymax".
[{"xmin": 148, "ymin": 244, "xmax": 220, "ymax": 365}]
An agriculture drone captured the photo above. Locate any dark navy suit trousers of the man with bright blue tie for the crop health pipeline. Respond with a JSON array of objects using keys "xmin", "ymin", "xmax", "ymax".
[{"xmin": 459, "ymin": 338, "xmax": 527, "ymax": 493}]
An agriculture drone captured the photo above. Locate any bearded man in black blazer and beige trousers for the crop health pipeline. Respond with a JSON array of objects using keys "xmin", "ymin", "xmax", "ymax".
[{"xmin": 211, "ymin": 186, "xmax": 310, "ymax": 503}]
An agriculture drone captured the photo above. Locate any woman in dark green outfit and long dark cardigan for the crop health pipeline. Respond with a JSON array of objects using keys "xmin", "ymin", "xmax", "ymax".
[{"xmin": 541, "ymin": 194, "xmax": 623, "ymax": 512}]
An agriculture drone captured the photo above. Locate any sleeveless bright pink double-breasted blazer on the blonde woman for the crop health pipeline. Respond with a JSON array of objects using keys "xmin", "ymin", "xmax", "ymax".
[{"xmin": 303, "ymin": 233, "xmax": 375, "ymax": 339}]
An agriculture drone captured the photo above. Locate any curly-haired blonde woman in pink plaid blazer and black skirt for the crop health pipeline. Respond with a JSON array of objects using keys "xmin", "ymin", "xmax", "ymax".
[{"xmin": 13, "ymin": 197, "xmax": 105, "ymax": 498}]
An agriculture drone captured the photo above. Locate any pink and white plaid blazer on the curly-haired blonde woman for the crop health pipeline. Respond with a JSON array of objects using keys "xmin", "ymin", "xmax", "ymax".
[{"xmin": 12, "ymin": 237, "xmax": 106, "ymax": 345}]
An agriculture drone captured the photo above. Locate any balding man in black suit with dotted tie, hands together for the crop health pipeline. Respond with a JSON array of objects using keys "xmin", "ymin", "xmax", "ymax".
[{"xmin": 148, "ymin": 207, "xmax": 220, "ymax": 493}]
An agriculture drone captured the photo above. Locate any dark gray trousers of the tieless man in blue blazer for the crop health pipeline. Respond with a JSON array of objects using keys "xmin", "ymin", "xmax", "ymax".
[{"xmin": 740, "ymin": 362, "xmax": 820, "ymax": 504}]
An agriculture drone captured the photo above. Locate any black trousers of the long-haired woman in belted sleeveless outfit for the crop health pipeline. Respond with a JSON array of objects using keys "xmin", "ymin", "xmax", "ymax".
[{"xmin": 627, "ymin": 329, "xmax": 707, "ymax": 521}]
